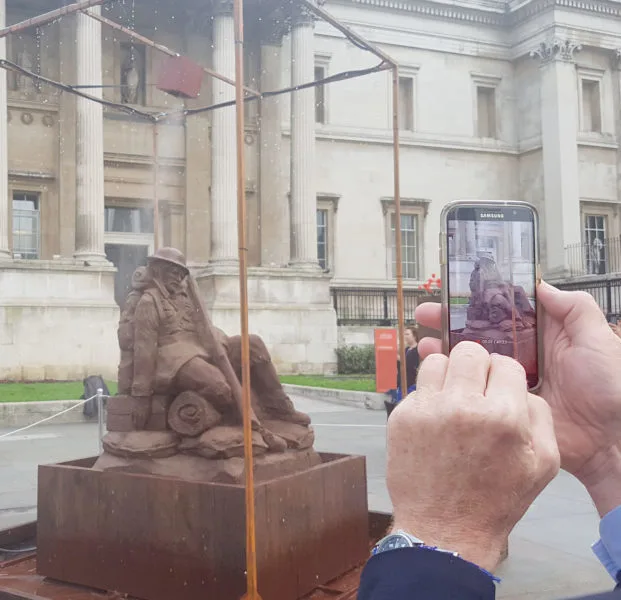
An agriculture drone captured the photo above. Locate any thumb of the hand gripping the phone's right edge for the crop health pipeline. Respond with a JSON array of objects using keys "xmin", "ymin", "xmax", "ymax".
[{"xmin": 537, "ymin": 281, "xmax": 608, "ymax": 338}]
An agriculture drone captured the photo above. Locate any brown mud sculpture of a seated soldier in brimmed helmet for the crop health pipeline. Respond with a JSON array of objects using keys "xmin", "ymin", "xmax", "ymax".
[{"xmin": 100, "ymin": 248, "xmax": 314, "ymax": 482}]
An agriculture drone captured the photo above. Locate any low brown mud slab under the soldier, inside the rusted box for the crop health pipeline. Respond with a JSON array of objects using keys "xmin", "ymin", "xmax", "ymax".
[{"xmin": 93, "ymin": 449, "xmax": 321, "ymax": 485}]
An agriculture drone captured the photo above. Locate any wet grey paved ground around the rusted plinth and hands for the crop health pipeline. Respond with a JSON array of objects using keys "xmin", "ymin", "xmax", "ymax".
[{"xmin": 0, "ymin": 399, "xmax": 612, "ymax": 600}]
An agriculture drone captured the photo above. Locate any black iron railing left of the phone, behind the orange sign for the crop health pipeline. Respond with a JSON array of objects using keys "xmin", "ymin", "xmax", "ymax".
[{"xmin": 332, "ymin": 287, "xmax": 436, "ymax": 326}]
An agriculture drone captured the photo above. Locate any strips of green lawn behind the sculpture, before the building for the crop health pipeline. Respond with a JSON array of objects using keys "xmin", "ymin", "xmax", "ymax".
[{"xmin": 0, "ymin": 375, "xmax": 375, "ymax": 403}]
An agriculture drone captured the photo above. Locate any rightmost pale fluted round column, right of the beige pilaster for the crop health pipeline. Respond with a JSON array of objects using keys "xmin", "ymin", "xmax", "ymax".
[{"xmin": 291, "ymin": 6, "xmax": 319, "ymax": 269}]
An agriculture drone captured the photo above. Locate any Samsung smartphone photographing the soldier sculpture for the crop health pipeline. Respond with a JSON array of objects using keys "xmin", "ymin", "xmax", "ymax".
[{"xmin": 440, "ymin": 200, "xmax": 542, "ymax": 391}]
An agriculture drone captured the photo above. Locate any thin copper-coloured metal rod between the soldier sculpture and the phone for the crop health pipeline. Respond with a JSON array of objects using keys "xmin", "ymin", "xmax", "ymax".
[{"xmin": 392, "ymin": 65, "xmax": 408, "ymax": 398}]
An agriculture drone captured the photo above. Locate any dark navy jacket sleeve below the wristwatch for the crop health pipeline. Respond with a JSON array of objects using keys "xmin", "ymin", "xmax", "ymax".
[{"xmin": 358, "ymin": 548, "xmax": 496, "ymax": 600}]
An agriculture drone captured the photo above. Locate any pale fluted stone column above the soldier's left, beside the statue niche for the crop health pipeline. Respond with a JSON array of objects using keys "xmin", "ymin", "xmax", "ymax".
[{"xmin": 75, "ymin": 7, "xmax": 106, "ymax": 262}]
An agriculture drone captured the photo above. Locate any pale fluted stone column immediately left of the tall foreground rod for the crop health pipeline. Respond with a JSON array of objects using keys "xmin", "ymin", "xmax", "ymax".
[{"xmin": 211, "ymin": 0, "xmax": 238, "ymax": 266}]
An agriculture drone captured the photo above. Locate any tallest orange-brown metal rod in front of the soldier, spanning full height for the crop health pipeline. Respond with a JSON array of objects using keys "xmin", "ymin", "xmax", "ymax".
[{"xmin": 233, "ymin": 0, "xmax": 260, "ymax": 600}]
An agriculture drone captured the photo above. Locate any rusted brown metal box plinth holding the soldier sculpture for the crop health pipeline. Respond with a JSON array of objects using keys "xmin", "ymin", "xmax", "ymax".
[{"xmin": 36, "ymin": 454, "xmax": 369, "ymax": 600}]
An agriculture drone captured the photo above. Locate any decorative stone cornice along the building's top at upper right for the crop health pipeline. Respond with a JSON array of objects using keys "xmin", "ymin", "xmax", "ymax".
[{"xmin": 333, "ymin": 0, "xmax": 621, "ymax": 28}]
